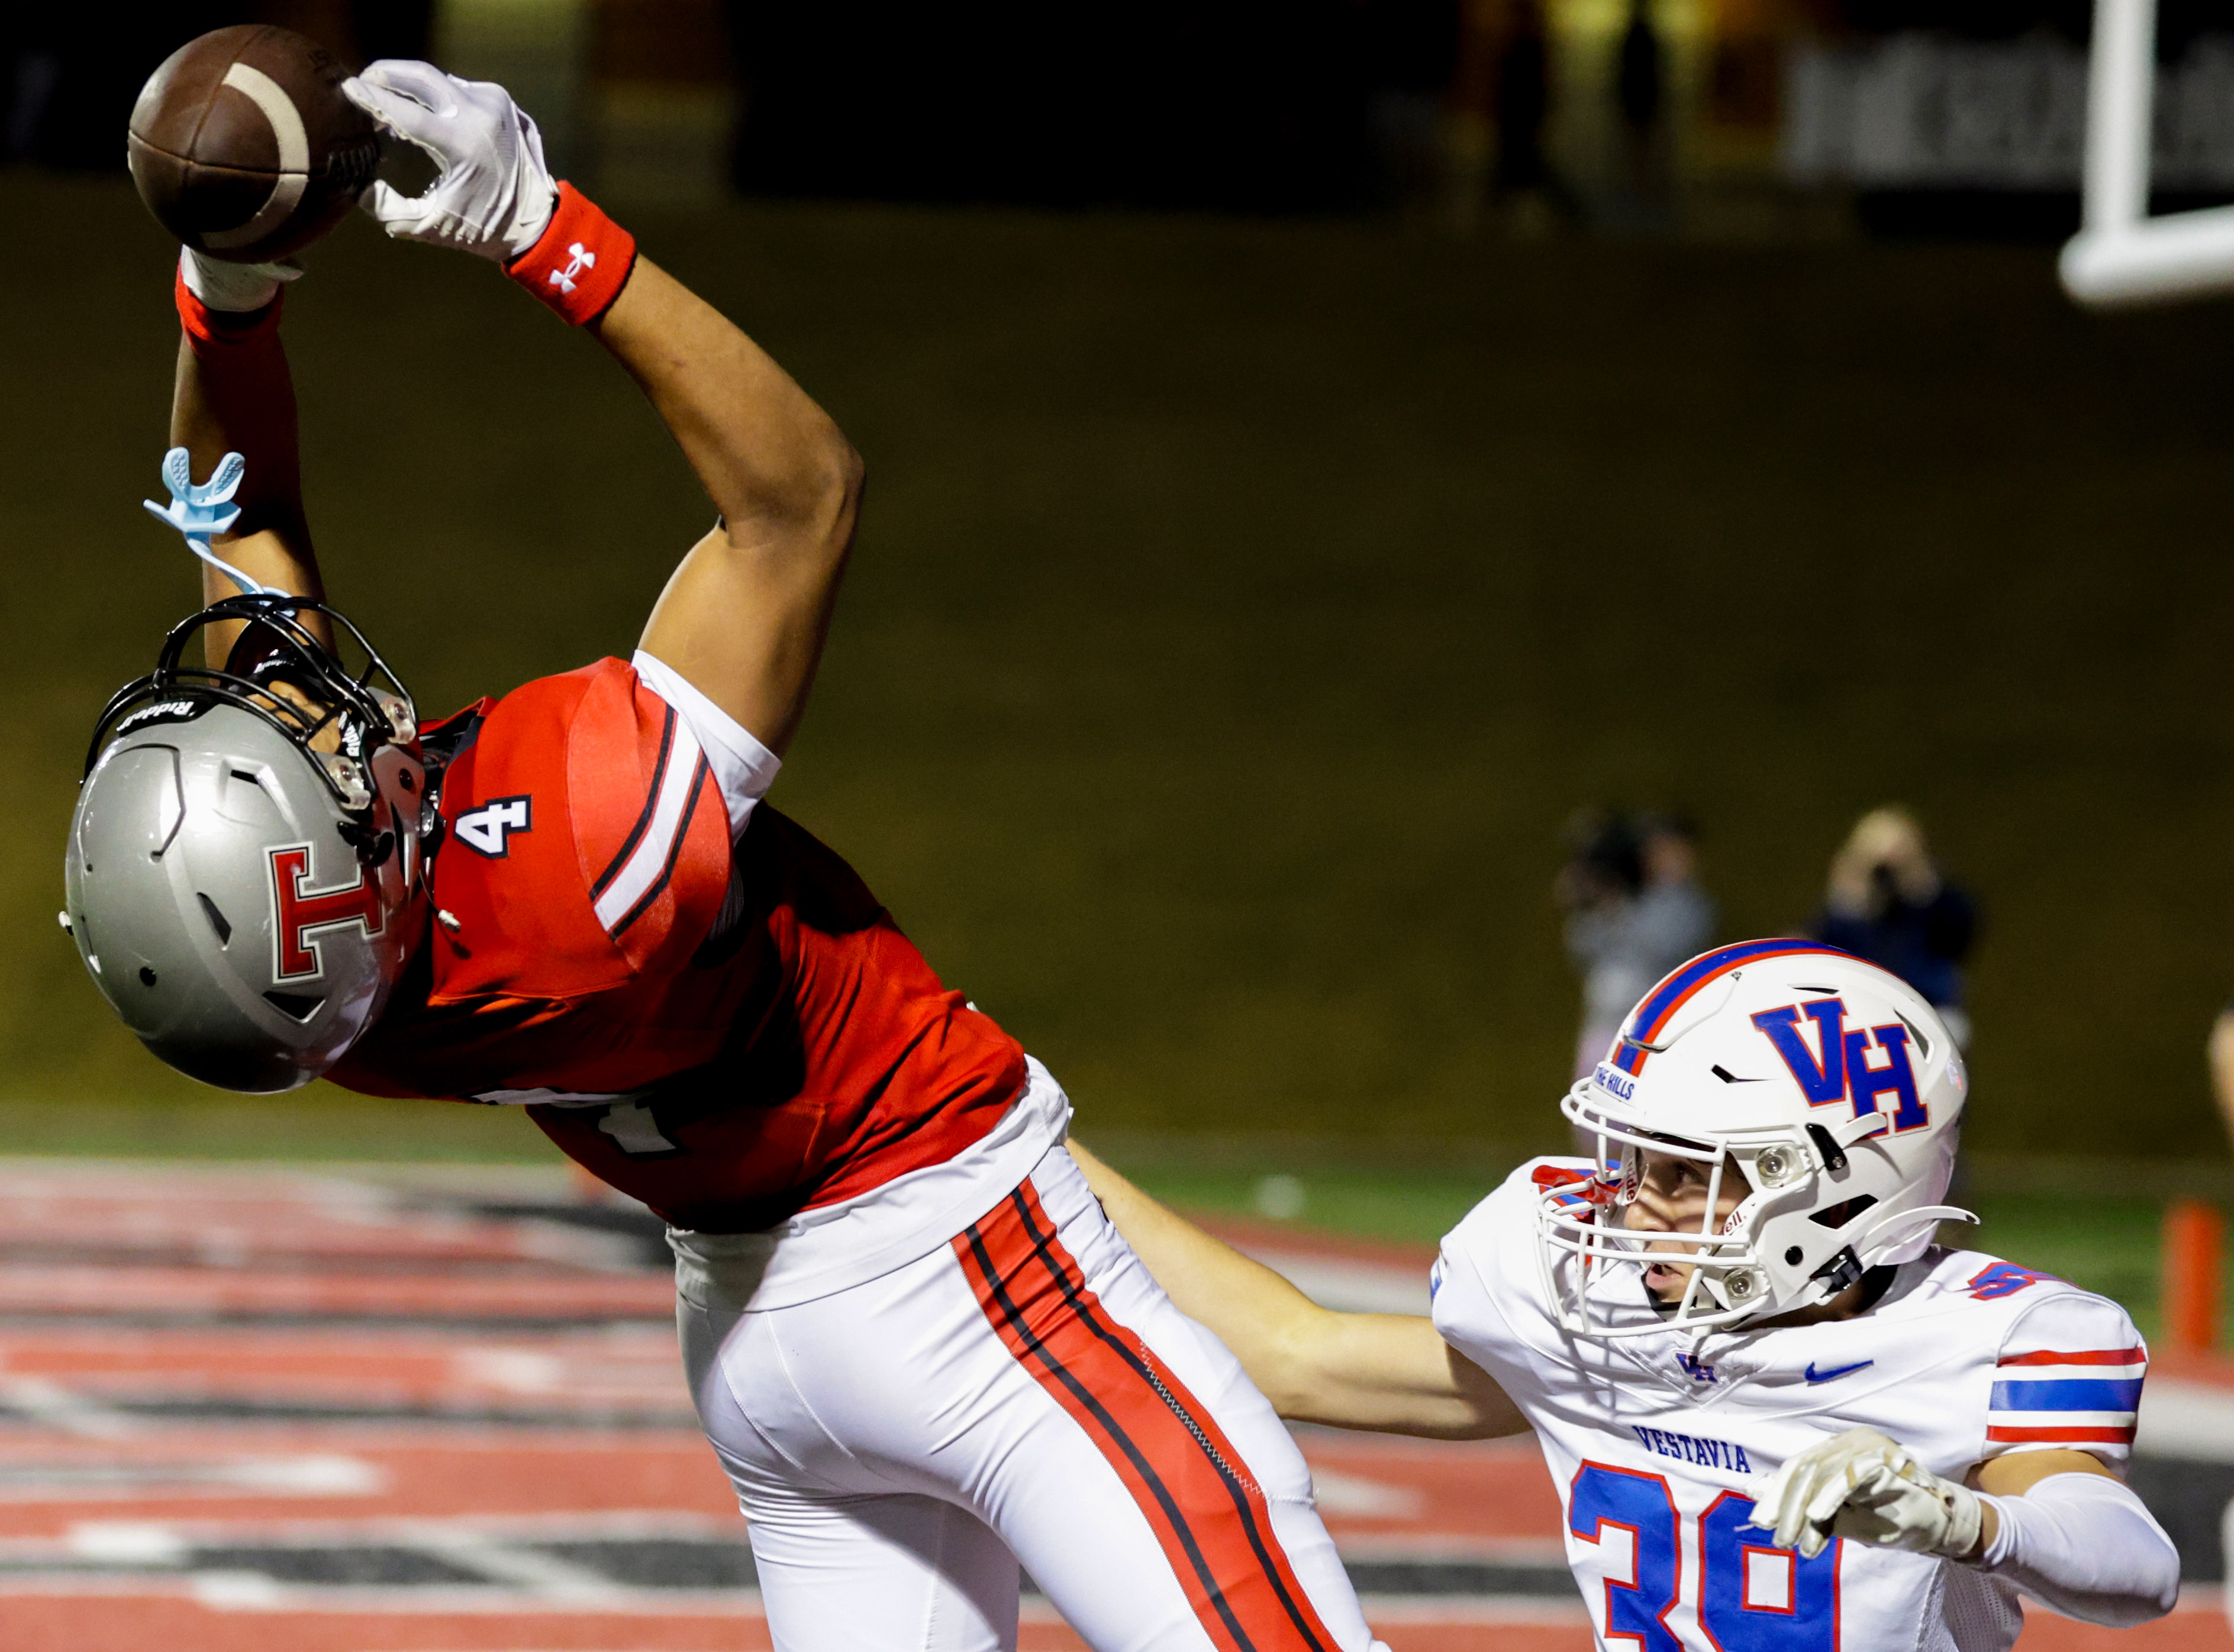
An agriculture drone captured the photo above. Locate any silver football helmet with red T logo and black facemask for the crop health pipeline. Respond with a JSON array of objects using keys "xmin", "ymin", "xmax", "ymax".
[{"xmin": 63, "ymin": 594, "xmax": 440, "ymax": 1094}]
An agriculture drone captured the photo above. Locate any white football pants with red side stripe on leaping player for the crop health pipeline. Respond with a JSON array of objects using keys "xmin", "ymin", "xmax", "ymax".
[{"xmin": 681, "ymin": 1147, "xmax": 1385, "ymax": 1652}]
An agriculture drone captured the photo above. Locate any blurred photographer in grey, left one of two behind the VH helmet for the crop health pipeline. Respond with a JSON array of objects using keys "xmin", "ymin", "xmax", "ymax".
[{"xmin": 1557, "ymin": 812, "xmax": 1716, "ymax": 1078}]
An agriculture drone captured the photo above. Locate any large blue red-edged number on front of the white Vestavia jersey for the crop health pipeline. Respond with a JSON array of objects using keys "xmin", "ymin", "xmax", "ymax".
[{"xmin": 1566, "ymin": 1462, "xmax": 1839, "ymax": 1652}]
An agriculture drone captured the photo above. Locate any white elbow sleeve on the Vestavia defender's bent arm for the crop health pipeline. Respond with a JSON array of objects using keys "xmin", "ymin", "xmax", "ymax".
[{"xmin": 1977, "ymin": 1473, "xmax": 2180, "ymax": 1630}]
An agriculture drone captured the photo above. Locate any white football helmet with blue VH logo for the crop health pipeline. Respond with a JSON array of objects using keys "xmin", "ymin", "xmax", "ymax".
[{"xmin": 1537, "ymin": 940, "xmax": 1977, "ymax": 1337}]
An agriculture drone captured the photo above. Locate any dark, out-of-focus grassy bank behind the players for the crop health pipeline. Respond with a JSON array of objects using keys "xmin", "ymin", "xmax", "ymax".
[{"xmin": 13, "ymin": 174, "xmax": 2234, "ymax": 1179}]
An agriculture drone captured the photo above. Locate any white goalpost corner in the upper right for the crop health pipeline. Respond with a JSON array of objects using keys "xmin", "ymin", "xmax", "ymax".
[{"xmin": 2058, "ymin": 0, "xmax": 2234, "ymax": 306}]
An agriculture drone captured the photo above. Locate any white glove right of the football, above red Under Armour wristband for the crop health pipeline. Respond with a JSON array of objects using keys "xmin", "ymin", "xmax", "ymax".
[{"xmin": 342, "ymin": 58, "xmax": 559, "ymax": 263}]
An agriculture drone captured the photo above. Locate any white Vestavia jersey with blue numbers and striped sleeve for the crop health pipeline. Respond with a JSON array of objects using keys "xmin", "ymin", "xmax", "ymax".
[{"xmin": 1434, "ymin": 1159, "xmax": 2147, "ymax": 1652}]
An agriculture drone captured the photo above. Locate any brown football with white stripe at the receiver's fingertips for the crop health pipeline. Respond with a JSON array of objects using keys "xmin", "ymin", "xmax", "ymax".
[{"xmin": 127, "ymin": 22, "xmax": 380, "ymax": 263}]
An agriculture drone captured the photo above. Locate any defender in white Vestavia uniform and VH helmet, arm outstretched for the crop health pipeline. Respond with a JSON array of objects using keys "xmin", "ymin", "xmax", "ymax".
[{"xmin": 1088, "ymin": 940, "xmax": 2178, "ymax": 1652}]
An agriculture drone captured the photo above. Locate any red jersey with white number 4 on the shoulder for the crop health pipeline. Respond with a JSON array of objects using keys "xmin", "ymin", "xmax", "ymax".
[{"xmin": 328, "ymin": 659, "xmax": 1026, "ymax": 1232}]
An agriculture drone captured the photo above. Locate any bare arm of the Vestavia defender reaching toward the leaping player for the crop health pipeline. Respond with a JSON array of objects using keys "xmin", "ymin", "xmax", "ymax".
[{"xmin": 1070, "ymin": 1141, "xmax": 1528, "ymax": 1440}]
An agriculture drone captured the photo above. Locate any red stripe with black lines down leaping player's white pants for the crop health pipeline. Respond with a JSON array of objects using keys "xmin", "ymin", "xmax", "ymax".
[{"xmin": 954, "ymin": 1183, "xmax": 1338, "ymax": 1652}]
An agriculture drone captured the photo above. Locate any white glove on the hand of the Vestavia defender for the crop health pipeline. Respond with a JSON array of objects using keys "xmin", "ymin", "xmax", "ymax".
[{"xmin": 1747, "ymin": 1429, "xmax": 1984, "ymax": 1560}]
